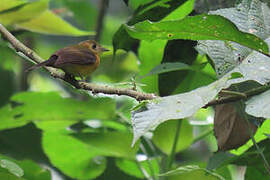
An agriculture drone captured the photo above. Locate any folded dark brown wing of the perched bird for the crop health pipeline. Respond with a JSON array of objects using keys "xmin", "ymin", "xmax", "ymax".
[{"xmin": 54, "ymin": 46, "xmax": 97, "ymax": 66}]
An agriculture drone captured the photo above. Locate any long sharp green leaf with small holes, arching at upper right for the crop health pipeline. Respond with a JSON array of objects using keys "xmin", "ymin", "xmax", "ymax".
[{"xmin": 125, "ymin": 15, "xmax": 268, "ymax": 53}]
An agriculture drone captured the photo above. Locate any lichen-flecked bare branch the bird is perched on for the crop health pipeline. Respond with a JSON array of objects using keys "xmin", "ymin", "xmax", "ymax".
[{"xmin": 0, "ymin": 24, "xmax": 156, "ymax": 101}]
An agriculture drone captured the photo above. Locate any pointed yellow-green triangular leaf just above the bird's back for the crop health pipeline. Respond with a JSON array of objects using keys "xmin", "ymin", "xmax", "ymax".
[{"xmin": 16, "ymin": 10, "xmax": 94, "ymax": 36}]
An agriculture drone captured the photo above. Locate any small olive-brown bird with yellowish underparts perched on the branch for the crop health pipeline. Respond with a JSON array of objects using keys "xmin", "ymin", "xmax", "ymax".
[{"xmin": 26, "ymin": 40, "xmax": 108, "ymax": 79}]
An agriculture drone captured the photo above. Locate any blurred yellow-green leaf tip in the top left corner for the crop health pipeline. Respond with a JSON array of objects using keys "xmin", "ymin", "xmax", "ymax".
[{"xmin": 0, "ymin": 0, "xmax": 49, "ymax": 26}]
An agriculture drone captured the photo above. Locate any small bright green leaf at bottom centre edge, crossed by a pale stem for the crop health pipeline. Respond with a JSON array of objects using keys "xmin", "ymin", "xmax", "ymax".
[{"xmin": 116, "ymin": 158, "xmax": 159, "ymax": 178}]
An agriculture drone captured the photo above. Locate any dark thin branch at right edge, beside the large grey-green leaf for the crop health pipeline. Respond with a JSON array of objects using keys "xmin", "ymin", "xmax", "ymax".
[{"xmin": 203, "ymin": 84, "xmax": 270, "ymax": 108}]
